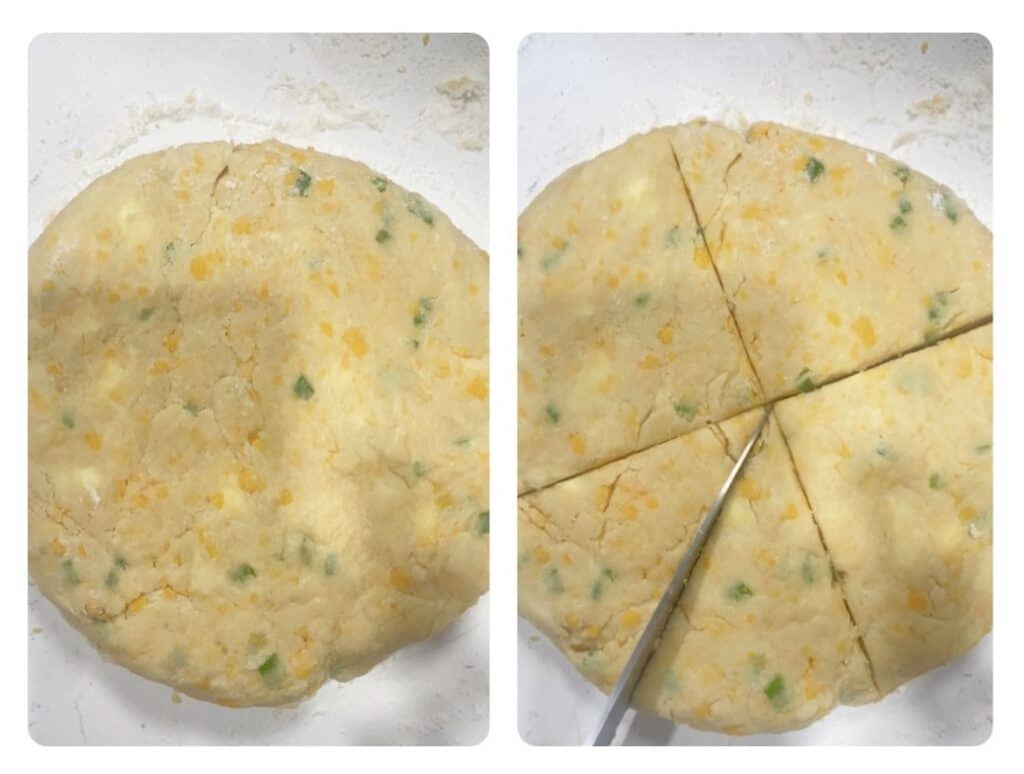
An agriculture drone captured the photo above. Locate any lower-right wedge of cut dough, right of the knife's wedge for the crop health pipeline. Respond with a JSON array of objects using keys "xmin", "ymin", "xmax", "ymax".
[{"xmin": 777, "ymin": 327, "xmax": 992, "ymax": 692}]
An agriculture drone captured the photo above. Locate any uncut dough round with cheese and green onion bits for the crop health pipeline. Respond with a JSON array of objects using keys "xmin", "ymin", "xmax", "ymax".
[{"xmin": 29, "ymin": 142, "xmax": 489, "ymax": 706}]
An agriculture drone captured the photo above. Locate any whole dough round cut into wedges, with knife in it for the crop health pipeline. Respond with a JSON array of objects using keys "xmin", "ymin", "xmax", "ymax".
[{"xmin": 519, "ymin": 122, "xmax": 991, "ymax": 734}]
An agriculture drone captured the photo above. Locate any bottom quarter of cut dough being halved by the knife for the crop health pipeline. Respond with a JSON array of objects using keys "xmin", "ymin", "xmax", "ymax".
[{"xmin": 519, "ymin": 412, "xmax": 876, "ymax": 733}]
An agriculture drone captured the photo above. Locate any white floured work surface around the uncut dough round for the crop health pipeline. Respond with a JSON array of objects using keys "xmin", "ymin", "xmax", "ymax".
[{"xmin": 28, "ymin": 35, "xmax": 488, "ymax": 744}]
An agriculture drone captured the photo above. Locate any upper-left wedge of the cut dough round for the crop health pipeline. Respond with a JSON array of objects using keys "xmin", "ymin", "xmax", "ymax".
[{"xmin": 519, "ymin": 126, "xmax": 760, "ymax": 490}]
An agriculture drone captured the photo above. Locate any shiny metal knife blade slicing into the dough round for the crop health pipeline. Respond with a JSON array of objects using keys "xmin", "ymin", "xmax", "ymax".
[{"xmin": 587, "ymin": 406, "xmax": 771, "ymax": 746}]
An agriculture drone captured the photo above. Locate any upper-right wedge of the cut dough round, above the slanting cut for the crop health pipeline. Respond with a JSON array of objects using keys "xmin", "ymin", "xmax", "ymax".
[{"xmin": 700, "ymin": 124, "xmax": 992, "ymax": 399}]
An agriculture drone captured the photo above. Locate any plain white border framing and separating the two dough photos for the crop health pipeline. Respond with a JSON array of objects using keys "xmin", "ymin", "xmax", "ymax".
[{"xmin": 0, "ymin": 0, "xmax": 1024, "ymax": 774}]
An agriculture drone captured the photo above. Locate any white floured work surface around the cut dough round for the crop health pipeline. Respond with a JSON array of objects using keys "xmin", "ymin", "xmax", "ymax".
[{"xmin": 518, "ymin": 35, "xmax": 992, "ymax": 745}]
